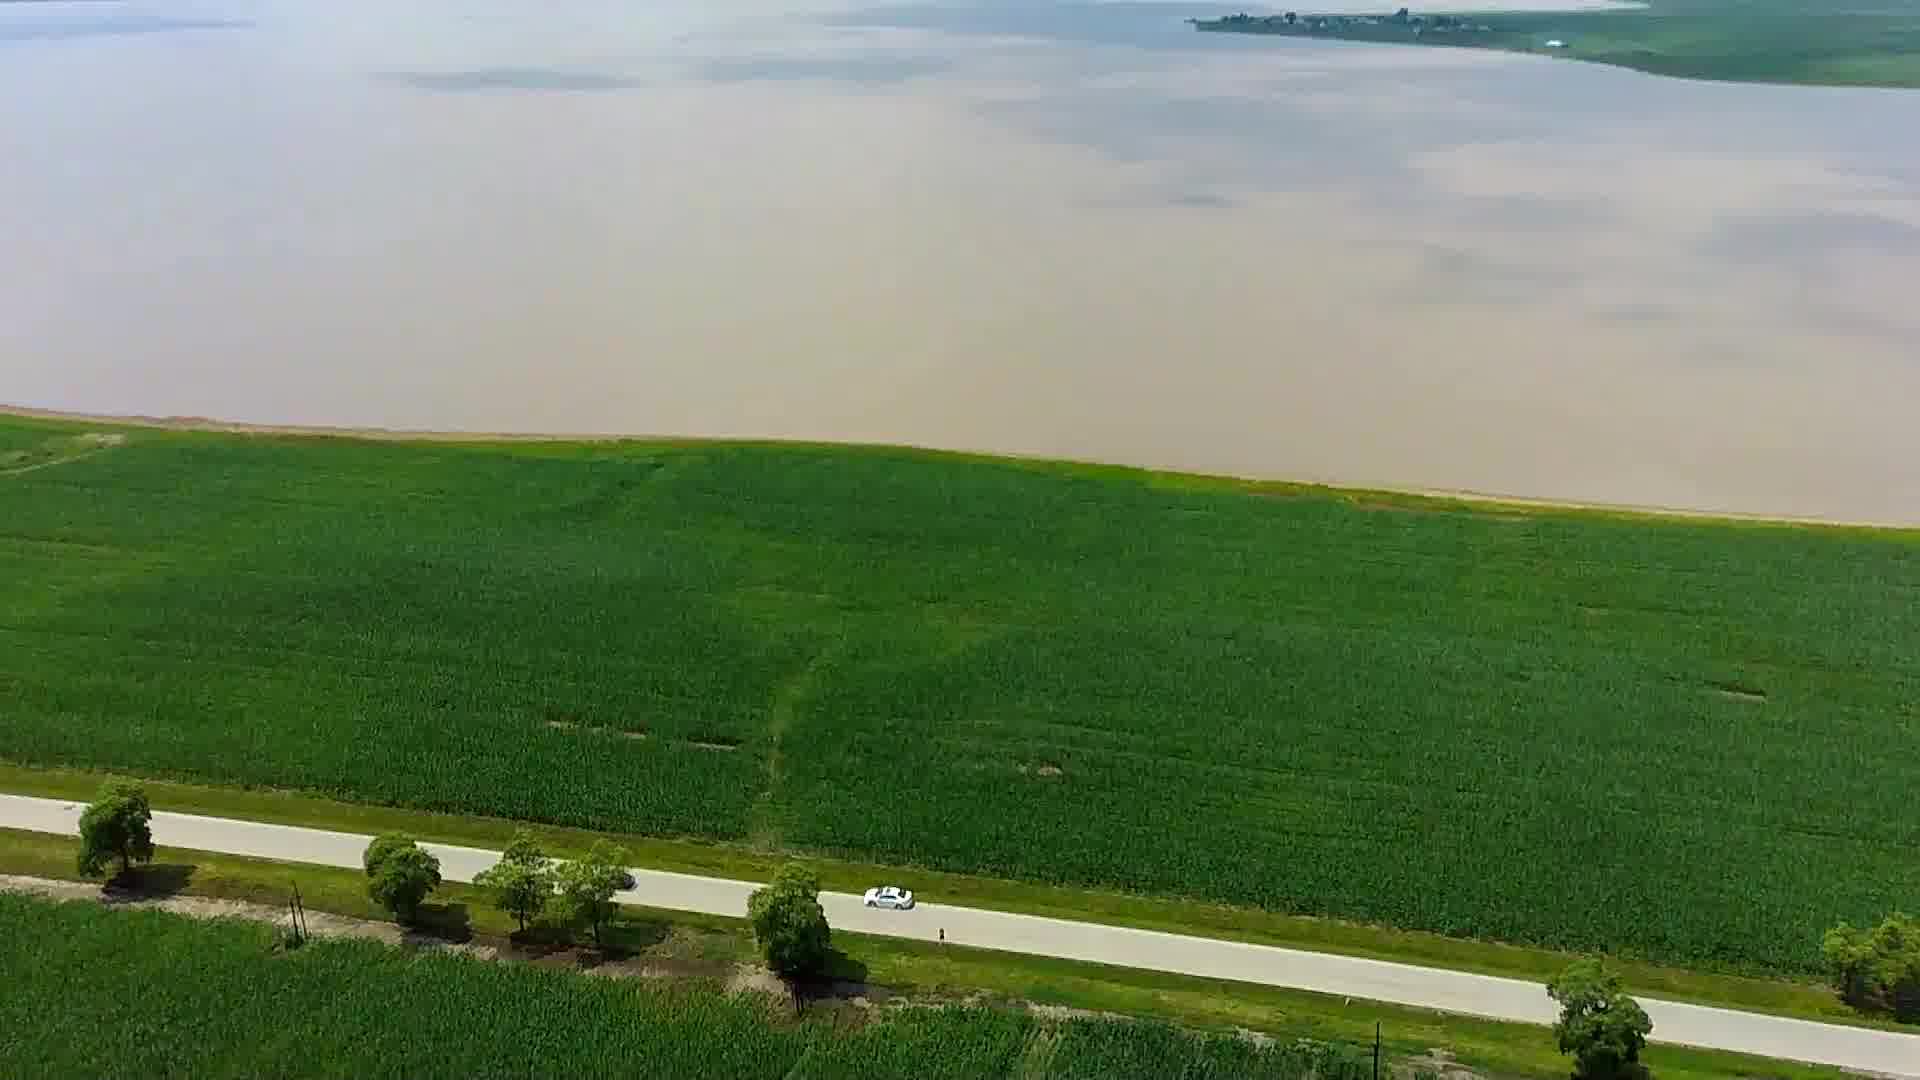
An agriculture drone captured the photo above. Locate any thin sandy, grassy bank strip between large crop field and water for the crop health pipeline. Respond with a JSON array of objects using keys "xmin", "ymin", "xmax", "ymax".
[{"xmin": 11, "ymin": 404, "xmax": 1920, "ymax": 534}]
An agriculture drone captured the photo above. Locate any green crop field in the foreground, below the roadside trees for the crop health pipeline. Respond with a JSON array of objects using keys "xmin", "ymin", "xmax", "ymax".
[{"xmin": 0, "ymin": 894, "xmax": 1365, "ymax": 1080}]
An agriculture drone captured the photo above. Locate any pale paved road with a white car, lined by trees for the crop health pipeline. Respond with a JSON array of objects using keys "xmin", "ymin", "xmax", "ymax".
[{"xmin": 0, "ymin": 796, "xmax": 1920, "ymax": 1080}]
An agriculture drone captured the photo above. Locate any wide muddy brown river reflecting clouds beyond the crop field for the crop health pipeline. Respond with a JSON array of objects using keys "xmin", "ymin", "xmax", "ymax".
[{"xmin": 0, "ymin": 0, "xmax": 1920, "ymax": 523}]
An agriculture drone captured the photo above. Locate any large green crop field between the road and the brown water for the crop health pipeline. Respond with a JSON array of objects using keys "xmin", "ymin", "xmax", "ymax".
[{"xmin": 0, "ymin": 421, "xmax": 1920, "ymax": 972}]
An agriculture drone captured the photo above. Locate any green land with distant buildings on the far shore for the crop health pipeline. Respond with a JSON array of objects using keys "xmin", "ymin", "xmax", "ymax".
[{"xmin": 1192, "ymin": 0, "xmax": 1920, "ymax": 86}]
